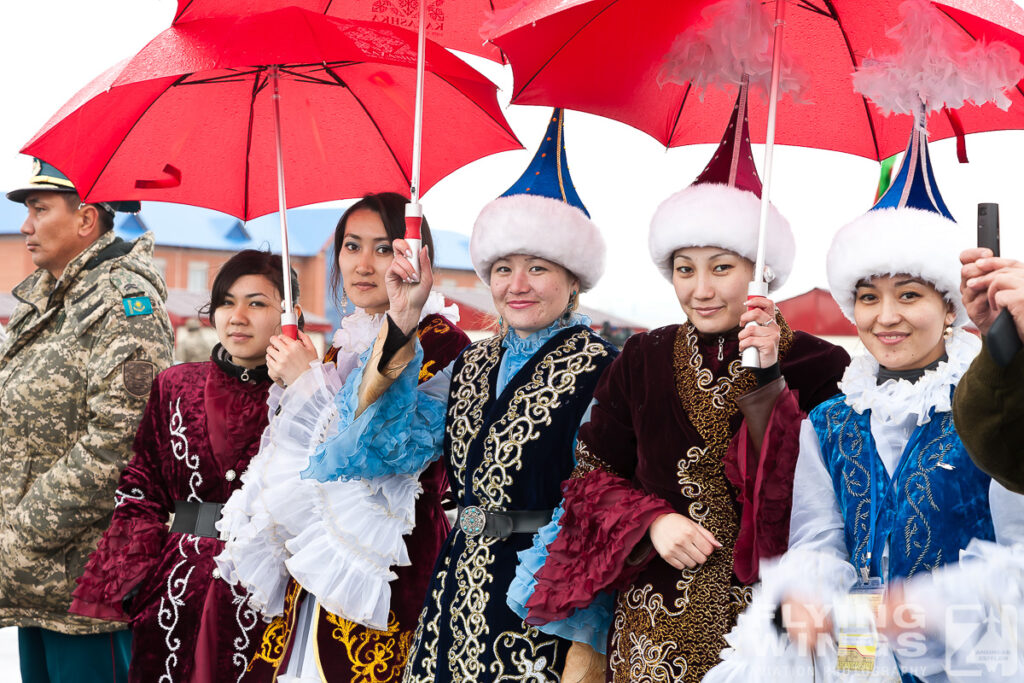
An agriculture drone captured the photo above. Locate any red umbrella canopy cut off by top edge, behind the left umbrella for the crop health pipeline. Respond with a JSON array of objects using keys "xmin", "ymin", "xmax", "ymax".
[{"xmin": 174, "ymin": 0, "xmax": 521, "ymax": 61}]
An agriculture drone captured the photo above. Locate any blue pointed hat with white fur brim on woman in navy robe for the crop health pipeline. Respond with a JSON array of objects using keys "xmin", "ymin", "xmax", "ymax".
[{"xmin": 469, "ymin": 109, "xmax": 605, "ymax": 291}]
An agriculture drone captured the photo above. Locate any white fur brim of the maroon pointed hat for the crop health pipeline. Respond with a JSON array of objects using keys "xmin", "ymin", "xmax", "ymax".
[{"xmin": 647, "ymin": 183, "xmax": 797, "ymax": 291}]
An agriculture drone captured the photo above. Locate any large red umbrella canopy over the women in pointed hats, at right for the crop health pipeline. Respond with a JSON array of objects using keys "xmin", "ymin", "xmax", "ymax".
[{"xmin": 492, "ymin": 0, "xmax": 1024, "ymax": 160}]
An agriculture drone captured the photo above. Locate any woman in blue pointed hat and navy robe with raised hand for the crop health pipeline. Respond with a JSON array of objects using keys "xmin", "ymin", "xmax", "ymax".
[{"xmin": 308, "ymin": 113, "xmax": 616, "ymax": 681}]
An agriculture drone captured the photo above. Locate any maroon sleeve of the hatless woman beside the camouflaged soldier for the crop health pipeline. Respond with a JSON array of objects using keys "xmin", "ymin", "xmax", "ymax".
[{"xmin": 70, "ymin": 378, "xmax": 170, "ymax": 622}]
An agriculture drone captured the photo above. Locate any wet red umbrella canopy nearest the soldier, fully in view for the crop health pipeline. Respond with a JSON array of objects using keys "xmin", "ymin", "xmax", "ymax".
[{"xmin": 23, "ymin": 7, "xmax": 521, "ymax": 220}]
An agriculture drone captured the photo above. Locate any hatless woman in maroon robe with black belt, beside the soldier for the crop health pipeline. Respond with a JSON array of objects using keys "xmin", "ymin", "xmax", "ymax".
[{"xmin": 71, "ymin": 250, "xmax": 298, "ymax": 683}]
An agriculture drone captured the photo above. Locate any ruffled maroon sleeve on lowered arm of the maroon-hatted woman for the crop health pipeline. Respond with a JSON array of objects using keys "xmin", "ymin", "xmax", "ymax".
[{"xmin": 526, "ymin": 469, "xmax": 675, "ymax": 625}]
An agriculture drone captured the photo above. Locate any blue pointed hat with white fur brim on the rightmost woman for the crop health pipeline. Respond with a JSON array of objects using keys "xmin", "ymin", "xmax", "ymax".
[{"xmin": 825, "ymin": 114, "xmax": 968, "ymax": 325}]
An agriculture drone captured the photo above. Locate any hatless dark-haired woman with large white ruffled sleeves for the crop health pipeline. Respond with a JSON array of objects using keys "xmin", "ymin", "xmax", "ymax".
[{"xmin": 221, "ymin": 193, "xmax": 469, "ymax": 683}]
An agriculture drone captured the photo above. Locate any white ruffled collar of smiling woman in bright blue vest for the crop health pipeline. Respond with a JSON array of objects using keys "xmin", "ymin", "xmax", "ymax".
[{"xmin": 839, "ymin": 328, "xmax": 981, "ymax": 425}]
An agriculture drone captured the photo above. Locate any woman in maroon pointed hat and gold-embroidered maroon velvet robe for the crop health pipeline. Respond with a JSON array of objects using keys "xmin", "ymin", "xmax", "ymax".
[{"xmin": 509, "ymin": 92, "xmax": 849, "ymax": 683}]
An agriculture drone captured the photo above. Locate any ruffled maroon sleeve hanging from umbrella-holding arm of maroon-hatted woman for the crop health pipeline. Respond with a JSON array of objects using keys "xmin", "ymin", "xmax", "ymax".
[{"xmin": 723, "ymin": 387, "xmax": 805, "ymax": 585}]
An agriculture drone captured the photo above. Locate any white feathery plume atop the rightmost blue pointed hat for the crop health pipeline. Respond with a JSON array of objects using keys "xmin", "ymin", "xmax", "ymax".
[{"xmin": 853, "ymin": 0, "xmax": 1024, "ymax": 116}]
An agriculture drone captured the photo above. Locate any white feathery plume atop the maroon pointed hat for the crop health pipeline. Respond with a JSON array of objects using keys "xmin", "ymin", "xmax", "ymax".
[{"xmin": 657, "ymin": 0, "xmax": 805, "ymax": 101}]
